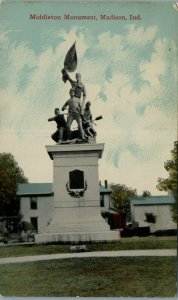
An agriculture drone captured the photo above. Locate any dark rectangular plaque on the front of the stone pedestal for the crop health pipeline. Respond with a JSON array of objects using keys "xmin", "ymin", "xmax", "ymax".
[{"xmin": 69, "ymin": 170, "xmax": 84, "ymax": 189}]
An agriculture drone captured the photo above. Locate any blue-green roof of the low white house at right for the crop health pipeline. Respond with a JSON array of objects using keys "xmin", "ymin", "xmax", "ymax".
[{"xmin": 131, "ymin": 196, "xmax": 175, "ymax": 205}]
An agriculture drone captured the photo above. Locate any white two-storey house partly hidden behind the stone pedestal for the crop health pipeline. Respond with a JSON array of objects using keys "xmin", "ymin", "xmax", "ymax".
[{"xmin": 17, "ymin": 183, "xmax": 111, "ymax": 233}]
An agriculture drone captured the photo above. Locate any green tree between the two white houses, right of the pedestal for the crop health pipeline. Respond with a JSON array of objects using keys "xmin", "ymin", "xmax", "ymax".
[{"xmin": 110, "ymin": 183, "xmax": 137, "ymax": 213}]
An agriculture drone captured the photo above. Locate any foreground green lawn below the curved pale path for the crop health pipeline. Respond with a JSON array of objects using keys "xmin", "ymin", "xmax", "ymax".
[{"xmin": 0, "ymin": 257, "xmax": 176, "ymax": 297}]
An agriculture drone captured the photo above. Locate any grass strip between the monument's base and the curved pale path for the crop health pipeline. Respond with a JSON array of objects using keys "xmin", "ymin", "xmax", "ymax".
[{"xmin": 0, "ymin": 236, "xmax": 177, "ymax": 258}]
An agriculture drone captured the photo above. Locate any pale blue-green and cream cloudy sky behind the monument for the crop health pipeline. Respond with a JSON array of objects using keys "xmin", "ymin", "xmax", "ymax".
[{"xmin": 0, "ymin": 1, "xmax": 178, "ymax": 195}]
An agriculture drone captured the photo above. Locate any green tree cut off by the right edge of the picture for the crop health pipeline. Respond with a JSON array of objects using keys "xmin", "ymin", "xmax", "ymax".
[{"xmin": 156, "ymin": 141, "xmax": 178, "ymax": 222}]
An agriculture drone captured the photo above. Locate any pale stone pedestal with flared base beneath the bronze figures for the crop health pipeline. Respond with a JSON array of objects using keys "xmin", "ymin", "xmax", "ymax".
[{"xmin": 35, "ymin": 144, "xmax": 119, "ymax": 243}]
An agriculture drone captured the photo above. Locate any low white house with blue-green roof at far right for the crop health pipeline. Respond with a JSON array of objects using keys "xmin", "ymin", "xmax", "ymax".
[{"xmin": 130, "ymin": 195, "xmax": 177, "ymax": 232}]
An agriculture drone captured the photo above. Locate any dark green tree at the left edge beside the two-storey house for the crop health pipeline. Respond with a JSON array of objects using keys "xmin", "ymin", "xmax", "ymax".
[{"xmin": 0, "ymin": 153, "xmax": 28, "ymax": 216}]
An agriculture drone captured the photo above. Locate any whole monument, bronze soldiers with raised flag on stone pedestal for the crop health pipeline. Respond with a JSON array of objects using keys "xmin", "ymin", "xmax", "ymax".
[{"xmin": 35, "ymin": 43, "xmax": 119, "ymax": 243}]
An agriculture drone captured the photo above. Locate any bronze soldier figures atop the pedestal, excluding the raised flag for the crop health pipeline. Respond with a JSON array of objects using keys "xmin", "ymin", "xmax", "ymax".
[{"xmin": 48, "ymin": 68, "xmax": 96, "ymax": 144}]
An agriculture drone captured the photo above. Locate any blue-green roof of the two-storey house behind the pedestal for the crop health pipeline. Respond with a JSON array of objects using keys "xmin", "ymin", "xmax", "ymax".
[{"xmin": 17, "ymin": 183, "xmax": 111, "ymax": 196}]
